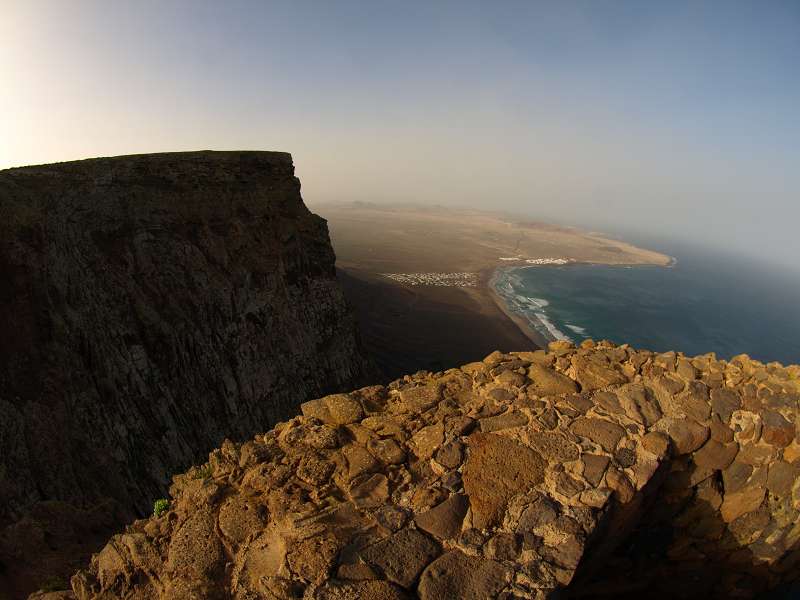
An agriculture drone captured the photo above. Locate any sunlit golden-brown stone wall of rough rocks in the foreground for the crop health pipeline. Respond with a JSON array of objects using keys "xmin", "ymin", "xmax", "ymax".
[{"xmin": 65, "ymin": 341, "xmax": 800, "ymax": 600}]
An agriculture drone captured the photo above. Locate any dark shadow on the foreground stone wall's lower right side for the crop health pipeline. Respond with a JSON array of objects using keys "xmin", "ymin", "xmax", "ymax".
[{"xmin": 564, "ymin": 464, "xmax": 800, "ymax": 600}]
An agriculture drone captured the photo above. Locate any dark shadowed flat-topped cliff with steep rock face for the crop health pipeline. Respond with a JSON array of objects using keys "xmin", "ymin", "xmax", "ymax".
[{"xmin": 0, "ymin": 152, "xmax": 370, "ymax": 597}]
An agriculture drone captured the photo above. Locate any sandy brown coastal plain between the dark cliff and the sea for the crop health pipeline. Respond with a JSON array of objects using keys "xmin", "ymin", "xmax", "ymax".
[{"xmin": 311, "ymin": 202, "xmax": 671, "ymax": 378}]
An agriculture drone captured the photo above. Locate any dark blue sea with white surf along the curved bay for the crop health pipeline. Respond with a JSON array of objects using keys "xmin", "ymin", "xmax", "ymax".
[{"xmin": 495, "ymin": 243, "xmax": 800, "ymax": 364}]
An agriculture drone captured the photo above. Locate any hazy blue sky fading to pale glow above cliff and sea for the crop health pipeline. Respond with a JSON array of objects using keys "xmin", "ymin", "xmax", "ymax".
[{"xmin": 0, "ymin": 0, "xmax": 800, "ymax": 271}]
